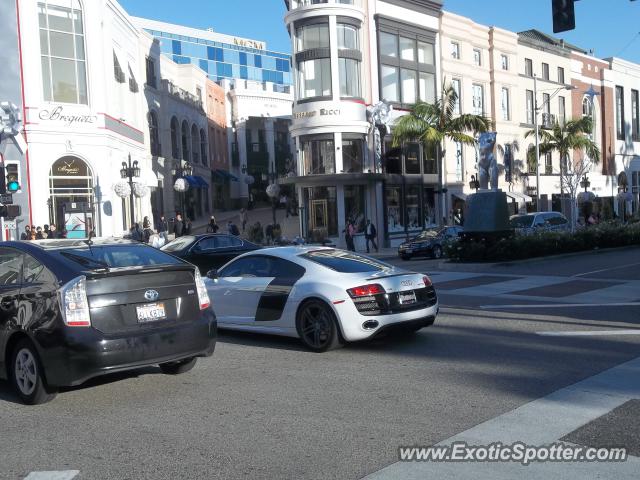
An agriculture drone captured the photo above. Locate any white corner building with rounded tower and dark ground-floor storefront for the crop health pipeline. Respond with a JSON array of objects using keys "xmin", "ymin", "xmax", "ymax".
[{"xmin": 285, "ymin": 0, "xmax": 441, "ymax": 248}]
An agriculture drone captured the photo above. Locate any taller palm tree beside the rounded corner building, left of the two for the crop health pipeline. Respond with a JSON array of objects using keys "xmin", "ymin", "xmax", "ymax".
[{"xmin": 393, "ymin": 85, "xmax": 491, "ymax": 225}]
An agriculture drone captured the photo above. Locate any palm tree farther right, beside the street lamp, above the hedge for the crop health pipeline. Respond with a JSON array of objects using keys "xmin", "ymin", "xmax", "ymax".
[{"xmin": 525, "ymin": 117, "xmax": 600, "ymax": 229}]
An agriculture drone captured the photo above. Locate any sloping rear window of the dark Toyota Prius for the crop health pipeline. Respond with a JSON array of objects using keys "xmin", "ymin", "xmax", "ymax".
[{"xmin": 60, "ymin": 245, "xmax": 182, "ymax": 268}]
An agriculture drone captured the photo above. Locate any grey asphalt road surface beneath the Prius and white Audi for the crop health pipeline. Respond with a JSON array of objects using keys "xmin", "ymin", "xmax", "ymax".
[{"xmin": 0, "ymin": 250, "xmax": 640, "ymax": 480}]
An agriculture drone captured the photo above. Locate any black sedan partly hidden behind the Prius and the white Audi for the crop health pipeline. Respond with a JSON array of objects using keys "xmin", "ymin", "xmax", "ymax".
[{"xmin": 161, "ymin": 233, "xmax": 262, "ymax": 275}]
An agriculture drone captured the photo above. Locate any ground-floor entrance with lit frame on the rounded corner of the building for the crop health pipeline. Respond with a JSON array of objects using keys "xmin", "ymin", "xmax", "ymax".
[{"xmin": 304, "ymin": 187, "xmax": 338, "ymax": 241}]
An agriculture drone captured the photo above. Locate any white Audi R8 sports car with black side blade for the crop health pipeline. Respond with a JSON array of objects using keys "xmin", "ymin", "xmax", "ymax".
[{"xmin": 206, "ymin": 247, "xmax": 438, "ymax": 352}]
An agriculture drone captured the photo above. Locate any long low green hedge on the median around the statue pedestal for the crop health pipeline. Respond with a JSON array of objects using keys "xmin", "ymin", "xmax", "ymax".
[{"xmin": 445, "ymin": 222, "xmax": 640, "ymax": 262}]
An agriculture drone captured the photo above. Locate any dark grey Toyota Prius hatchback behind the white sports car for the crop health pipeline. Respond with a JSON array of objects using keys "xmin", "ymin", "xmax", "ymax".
[{"xmin": 0, "ymin": 240, "xmax": 216, "ymax": 404}]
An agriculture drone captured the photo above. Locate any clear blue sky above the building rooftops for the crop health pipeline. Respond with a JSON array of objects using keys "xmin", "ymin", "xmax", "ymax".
[{"xmin": 119, "ymin": 0, "xmax": 640, "ymax": 63}]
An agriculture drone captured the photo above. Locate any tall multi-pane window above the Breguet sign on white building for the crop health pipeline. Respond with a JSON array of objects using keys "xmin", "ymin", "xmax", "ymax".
[{"xmin": 38, "ymin": 0, "xmax": 88, "ymax": 105}]
